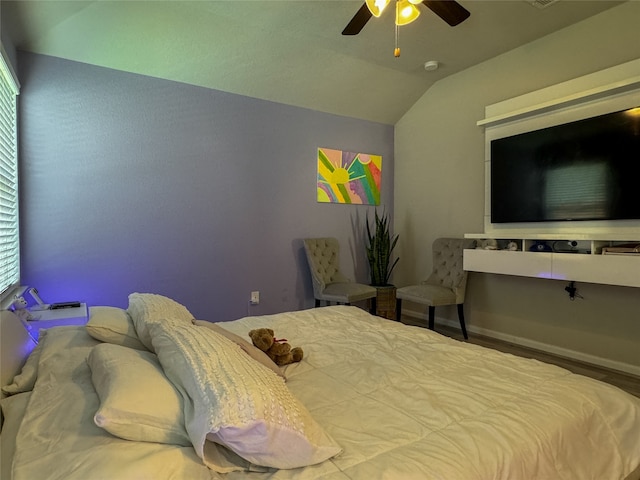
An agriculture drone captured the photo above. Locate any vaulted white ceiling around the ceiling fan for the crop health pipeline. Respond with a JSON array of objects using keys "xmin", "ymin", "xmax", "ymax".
[{"xmin": 1, "ymin": 0, "xmax": 622, "ymax": 124}]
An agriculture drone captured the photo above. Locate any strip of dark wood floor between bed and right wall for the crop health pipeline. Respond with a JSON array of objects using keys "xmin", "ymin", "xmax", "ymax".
[{"xmin": 402, "ymin": 315, "xmax": 640, "ymax": 397}]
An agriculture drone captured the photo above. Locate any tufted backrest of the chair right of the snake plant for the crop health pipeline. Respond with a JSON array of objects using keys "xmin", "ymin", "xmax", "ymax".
[{"xmin": 423, "ymin": 238, "xmax": 475, "ymax": 303}]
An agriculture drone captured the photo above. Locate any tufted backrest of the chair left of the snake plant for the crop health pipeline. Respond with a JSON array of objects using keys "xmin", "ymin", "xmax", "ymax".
[{"xmin": 304, "ymin": 238, "xmax": 349, "ymax": 296}]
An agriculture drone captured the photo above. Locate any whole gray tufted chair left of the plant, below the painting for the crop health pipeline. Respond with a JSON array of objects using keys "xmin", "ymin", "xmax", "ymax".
[{"xmin": 304, "ymin": 238, "xmax": 377, "ymax": 312}]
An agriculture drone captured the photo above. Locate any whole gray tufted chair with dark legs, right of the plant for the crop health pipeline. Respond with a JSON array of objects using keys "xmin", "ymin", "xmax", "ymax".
[{"xmin": 396, "ymin": 238, "xmax": 475, "ymax": 338}]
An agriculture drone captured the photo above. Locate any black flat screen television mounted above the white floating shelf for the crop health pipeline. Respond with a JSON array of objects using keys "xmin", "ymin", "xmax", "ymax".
[{"xmin": 491, "ymin": 108, "xmax": 640, "ymax": 223}]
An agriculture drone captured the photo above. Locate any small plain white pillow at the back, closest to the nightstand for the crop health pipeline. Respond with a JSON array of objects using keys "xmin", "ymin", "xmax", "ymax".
[{"xmin": 86, "ymin": 307, "xmax": 146, "ymax": 350}]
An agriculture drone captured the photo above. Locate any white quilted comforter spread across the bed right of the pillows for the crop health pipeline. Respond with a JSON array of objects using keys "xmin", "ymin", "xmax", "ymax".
[{"xmin": 219, "ymin": 307, "xmax": 640, "ymax": 480}]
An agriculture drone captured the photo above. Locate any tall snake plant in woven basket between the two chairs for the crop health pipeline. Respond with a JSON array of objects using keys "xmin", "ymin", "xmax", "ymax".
[{"xmin": 366, "ymin": 210, "xmax": 400, "ymax": 319}]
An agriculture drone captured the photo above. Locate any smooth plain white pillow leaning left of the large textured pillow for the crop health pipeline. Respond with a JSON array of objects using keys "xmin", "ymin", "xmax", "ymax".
[{"xmin": 87, "ymin": 343, "xmax": 191, "ymax": 446}]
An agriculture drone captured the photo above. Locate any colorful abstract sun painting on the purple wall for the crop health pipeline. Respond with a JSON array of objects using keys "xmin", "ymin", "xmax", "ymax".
[{"xmin": 317, "ymin": 148, "xmax": 382, "ymax": 205}]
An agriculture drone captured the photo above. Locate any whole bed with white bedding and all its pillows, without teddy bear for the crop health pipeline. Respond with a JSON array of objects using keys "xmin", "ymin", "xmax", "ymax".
[{"xmin": 0, "ymin": 294, "xmax": 640, "ymax": 480}]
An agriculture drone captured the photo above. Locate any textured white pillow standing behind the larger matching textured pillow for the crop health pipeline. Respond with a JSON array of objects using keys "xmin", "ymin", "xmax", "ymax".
[{"xmin": 127, "ymin": 293, "xmax": 193, "ymax": 352}]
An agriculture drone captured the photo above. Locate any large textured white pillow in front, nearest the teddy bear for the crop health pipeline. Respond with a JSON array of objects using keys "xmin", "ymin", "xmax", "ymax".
[{"xmin": 150, "ymin": 322, "xmax": 342, "ymax": 469}]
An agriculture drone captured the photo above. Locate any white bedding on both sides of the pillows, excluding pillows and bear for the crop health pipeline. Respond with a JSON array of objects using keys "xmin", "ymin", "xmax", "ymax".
[{"xmin": 7, "ymin": 307, "xmax": 640, "ymax": 480}]
